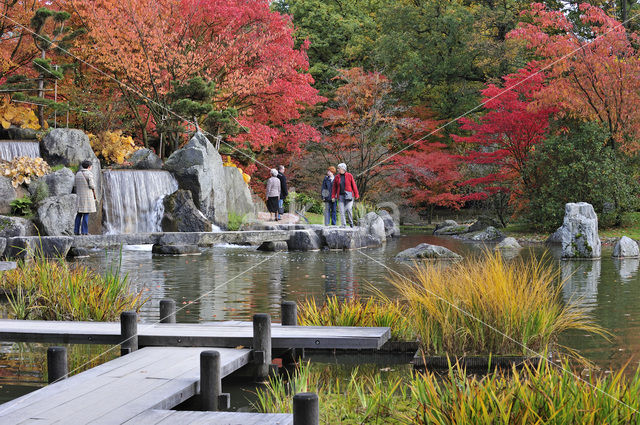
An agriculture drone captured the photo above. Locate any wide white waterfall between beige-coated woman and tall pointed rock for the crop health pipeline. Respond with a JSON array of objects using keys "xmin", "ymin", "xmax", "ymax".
[{"xmin": 102, "ymin": 170, "xmax": 178, "ymax": 234}]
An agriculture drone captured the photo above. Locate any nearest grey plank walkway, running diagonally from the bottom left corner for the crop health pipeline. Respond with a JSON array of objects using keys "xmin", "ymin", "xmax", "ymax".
[{"xmin": 0, "ymin": 347, "xmax": 293, "ymax": 425}]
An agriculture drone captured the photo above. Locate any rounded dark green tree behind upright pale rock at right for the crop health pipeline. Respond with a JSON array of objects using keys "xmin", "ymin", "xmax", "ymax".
[{"xmin": 524, "ymin": 122, "xmax": 640, "ymax": 231}]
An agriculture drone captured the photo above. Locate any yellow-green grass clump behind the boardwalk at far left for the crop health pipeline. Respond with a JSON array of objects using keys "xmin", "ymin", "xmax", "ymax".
[{"xmin": 0, "ymin": 256, "xmax": 146, "ymax": 321}]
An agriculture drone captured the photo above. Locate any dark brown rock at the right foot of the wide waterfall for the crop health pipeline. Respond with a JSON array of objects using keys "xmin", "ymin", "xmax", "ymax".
[{"xmin": 162, "ymin": 189, "xmax": 212, "ymax": 232}]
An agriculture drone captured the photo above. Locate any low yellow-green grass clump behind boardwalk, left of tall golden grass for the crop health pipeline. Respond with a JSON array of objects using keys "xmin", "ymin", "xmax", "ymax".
[{"xmin": 298, "ymin": 294, "xmax": 416, "ymax": 341}]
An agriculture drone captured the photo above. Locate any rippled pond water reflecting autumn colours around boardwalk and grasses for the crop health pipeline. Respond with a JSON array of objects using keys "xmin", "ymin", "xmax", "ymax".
[{"xmin": 0, "ymin": 233, "xmax": 640, "ymax": 402}]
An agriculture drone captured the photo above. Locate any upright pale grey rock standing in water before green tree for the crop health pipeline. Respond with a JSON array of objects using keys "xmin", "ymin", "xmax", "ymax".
[{"xmin": 561, "ymin": 202, "xmax": 601, "ymax": 258}]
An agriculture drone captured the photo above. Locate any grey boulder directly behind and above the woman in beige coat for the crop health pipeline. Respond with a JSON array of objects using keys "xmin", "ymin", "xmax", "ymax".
[{"xmin": 40, "ymin": 128, "xmax": 102, "ymax": 200}]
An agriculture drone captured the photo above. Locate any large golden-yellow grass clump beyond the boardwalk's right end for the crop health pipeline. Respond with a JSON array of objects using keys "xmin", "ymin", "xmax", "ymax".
[{"xmin": 389, "ymin": 252, "xmax": 606, "ymax": 356}]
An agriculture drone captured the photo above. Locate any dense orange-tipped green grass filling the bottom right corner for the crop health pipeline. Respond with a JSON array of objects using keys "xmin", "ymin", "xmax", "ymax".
[{"xmin": 411, "ymin": 364, "xmax": 640, "ymax": 425}]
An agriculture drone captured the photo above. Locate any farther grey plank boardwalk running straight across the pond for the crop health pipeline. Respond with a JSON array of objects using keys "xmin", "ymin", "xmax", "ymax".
[{"xmin": 0, "ymin": 320, "xmax": 391, "ymax": 349}]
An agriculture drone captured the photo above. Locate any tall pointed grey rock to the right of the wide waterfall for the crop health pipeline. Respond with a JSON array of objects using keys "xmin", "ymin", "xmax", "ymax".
[{"xmin": 164, "ymin": 132, "xmax": 228, "ymax": 227}]
